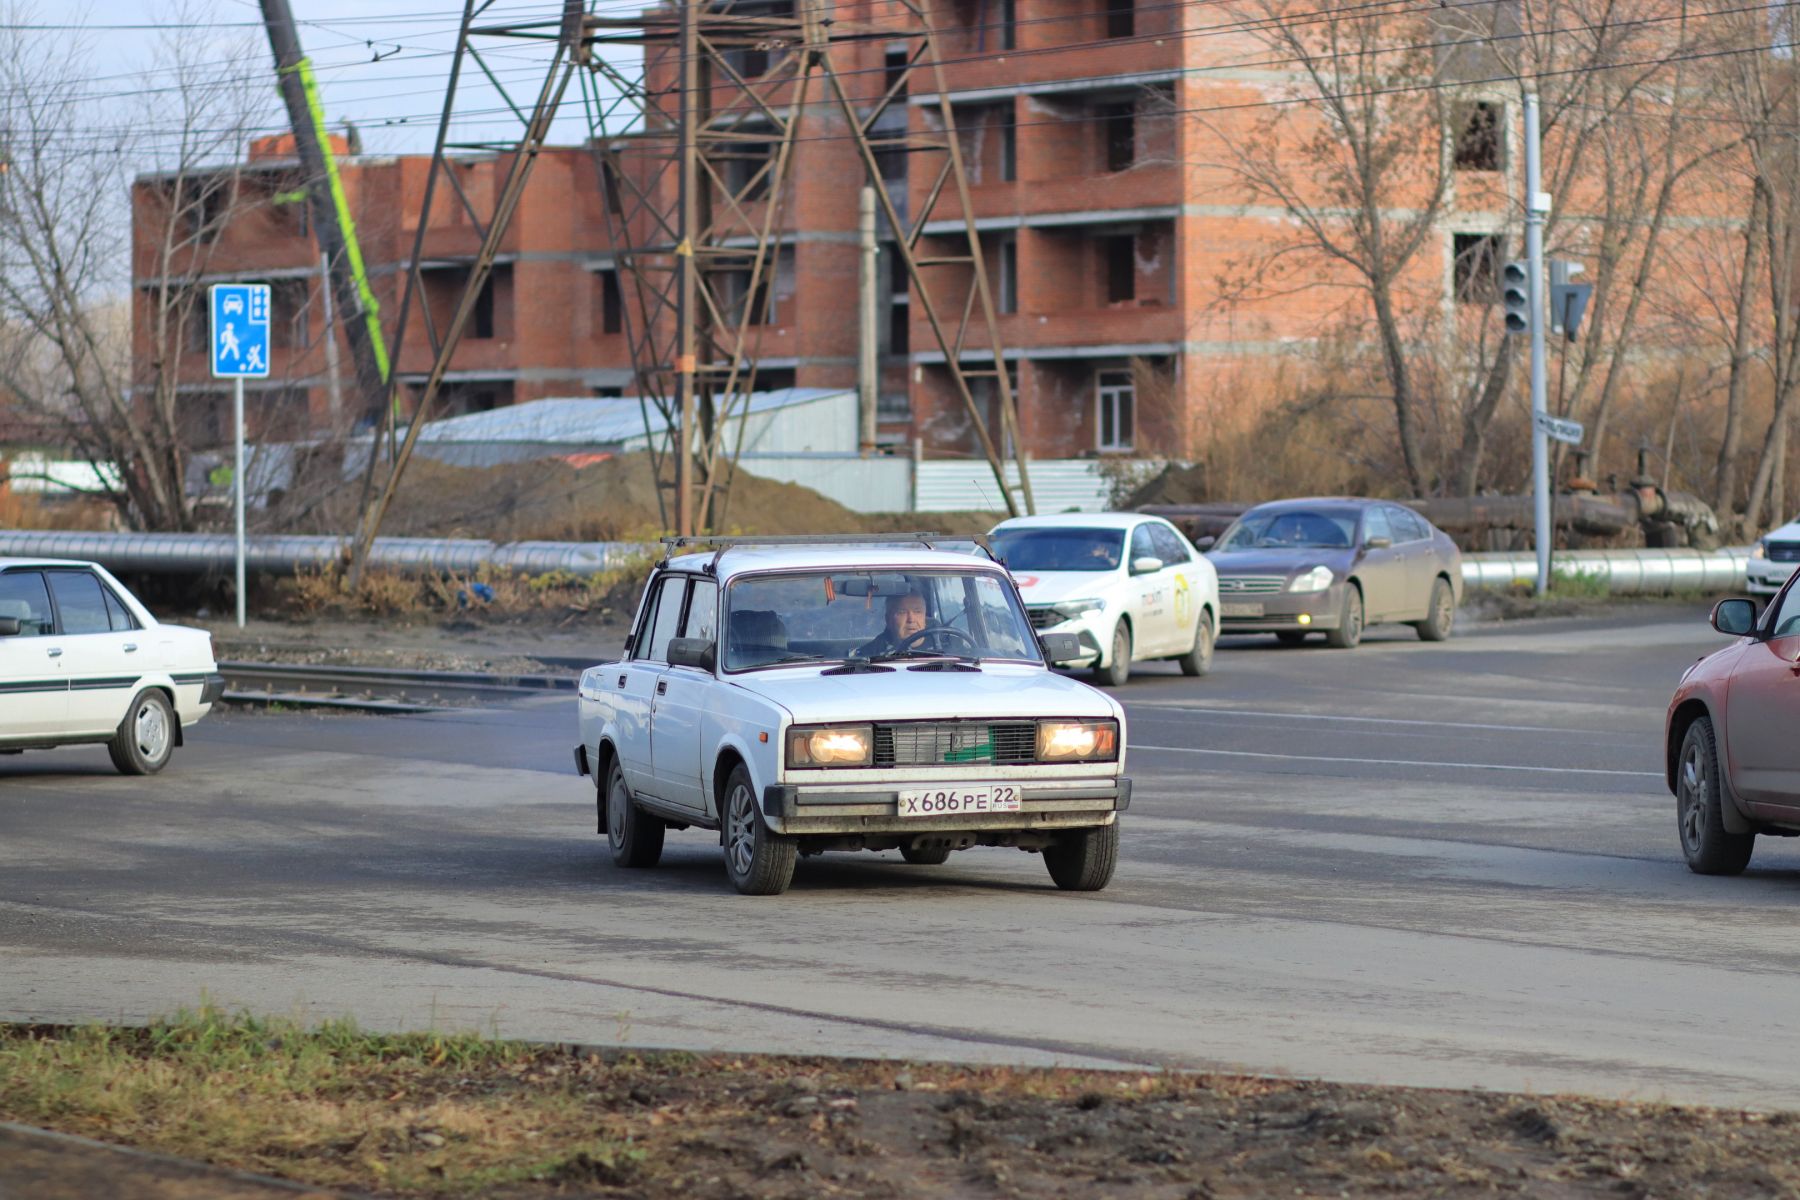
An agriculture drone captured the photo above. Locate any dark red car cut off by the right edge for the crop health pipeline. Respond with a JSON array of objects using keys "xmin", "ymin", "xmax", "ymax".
[{"xmin": 1665, "ymin": 579, "xmax": 1800, "ymax": 874}]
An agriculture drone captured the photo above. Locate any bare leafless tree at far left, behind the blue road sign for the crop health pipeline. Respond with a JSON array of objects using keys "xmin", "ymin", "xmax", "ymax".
[{"xmin": 0, "ymin": 7, "xmax": 268, "ymax": 529}]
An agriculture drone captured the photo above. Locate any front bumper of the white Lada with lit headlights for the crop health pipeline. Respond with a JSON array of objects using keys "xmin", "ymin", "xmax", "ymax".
[{"xmin": 763, "ymin": 775, "xmax": 1130, "ymax": 844}]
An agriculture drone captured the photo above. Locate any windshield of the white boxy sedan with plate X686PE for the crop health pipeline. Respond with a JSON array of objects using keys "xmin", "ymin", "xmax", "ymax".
[{"xmin": 724, "ymin": 570, "xmax": 1042, "ymax": 671}]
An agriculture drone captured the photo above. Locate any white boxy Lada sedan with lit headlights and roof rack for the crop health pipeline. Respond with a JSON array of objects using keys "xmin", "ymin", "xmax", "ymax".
[{"xmin": 574, "ymin": 540, "xmax": 1130, "ymax": 894}]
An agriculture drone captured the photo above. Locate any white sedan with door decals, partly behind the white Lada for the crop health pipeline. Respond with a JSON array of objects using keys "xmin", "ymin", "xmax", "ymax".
[{"xmin": 988, "ymin": 513, "xmax": 1219, "ymax": 687}]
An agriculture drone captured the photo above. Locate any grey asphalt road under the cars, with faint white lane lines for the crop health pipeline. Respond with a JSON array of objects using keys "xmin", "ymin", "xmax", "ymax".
[{"xmin": 0, "ymin": 608, "xmax": 1800, "ymax": 1106}]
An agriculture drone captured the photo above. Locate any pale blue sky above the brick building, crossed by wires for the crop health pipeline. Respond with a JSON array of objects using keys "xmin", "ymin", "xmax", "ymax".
[{"xmin": 73, "ymin": 0, "xmax": 639, "ymax": 164}]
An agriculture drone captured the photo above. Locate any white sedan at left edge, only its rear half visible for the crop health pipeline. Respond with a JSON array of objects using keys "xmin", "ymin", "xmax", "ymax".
[{"xmin": 0, "ymin": 558, "xmax": 225, "ymax": 775}]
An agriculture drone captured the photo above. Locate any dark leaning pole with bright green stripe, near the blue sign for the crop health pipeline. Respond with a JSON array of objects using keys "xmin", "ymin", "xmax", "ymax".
[{"xmin": 261, "ymin": 0, "xmax": 387, "ymax": 420}]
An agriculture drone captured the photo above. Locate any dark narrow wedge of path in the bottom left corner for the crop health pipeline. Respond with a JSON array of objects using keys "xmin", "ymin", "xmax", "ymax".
[{"xmin": 0, "ymin": 1121, "xmax": 347, "ymax": 1200}]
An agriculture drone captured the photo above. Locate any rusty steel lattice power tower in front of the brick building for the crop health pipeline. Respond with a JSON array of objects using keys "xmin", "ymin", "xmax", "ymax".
[{"xmin": 353, "ymin": 0, "xmax": 1033, "ymax": 572}]
